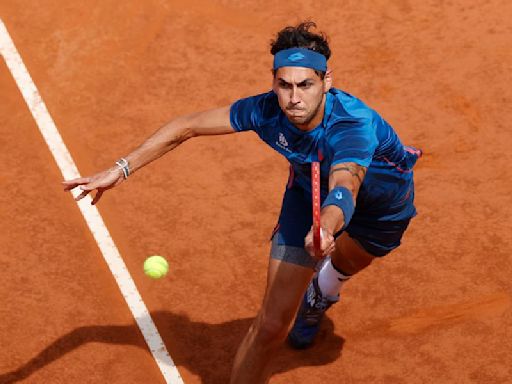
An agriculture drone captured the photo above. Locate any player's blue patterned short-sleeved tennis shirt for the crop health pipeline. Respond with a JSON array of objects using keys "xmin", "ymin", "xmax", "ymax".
[{"xmin": 230, "ymin": 88, "xmax": 419, "ymax": 221}]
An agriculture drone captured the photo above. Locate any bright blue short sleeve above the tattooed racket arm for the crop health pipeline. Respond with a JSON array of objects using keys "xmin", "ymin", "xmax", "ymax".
[{"xmin": 328, "ymin": 119, "xmax": 378, "ymax": 167}]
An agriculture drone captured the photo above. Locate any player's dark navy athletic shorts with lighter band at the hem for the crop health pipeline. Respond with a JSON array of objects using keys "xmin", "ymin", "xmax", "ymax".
[{"xmin": 270, "ymin": 185, "xmax": 411, "ymax": 269}]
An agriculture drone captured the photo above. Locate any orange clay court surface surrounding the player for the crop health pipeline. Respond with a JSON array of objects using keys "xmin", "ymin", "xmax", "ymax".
[{"xmin": 0, "ymin": 0, "xmax": 512, "ymax": 384}]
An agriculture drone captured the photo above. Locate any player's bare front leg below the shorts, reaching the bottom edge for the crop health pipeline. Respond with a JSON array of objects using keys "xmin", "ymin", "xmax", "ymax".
[{"xmin": 230, "ymin": 259, "xmax": 314, "ymax": 384}]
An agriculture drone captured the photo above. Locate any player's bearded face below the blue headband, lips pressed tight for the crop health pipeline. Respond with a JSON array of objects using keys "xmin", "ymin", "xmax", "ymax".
[{"xmin": 272, "ymin": 67, "xmax": 331, "ymax": 130}]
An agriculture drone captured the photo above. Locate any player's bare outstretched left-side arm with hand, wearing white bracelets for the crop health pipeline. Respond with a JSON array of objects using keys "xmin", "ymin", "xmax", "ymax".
[{"xmin": 62, "ymin": 106, "xmax": 235, "ymax": 204}]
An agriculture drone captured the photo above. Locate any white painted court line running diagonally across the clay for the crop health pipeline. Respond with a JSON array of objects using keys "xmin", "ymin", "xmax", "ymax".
[{"xmin": 0, "ymin": 19, "xmax": 183, "ymax": 384}]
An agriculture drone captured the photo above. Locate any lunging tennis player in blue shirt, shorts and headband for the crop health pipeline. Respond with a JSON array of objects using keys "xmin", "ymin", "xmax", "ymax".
[{"xmin": 64, "ymin": 22, "xmax": 421, "ymax": 384}]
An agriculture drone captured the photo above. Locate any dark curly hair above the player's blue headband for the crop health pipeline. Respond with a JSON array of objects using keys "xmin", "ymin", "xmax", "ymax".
[{"xmin": 270, "ymin": 21, "xmax": 331, "ymax": 60}]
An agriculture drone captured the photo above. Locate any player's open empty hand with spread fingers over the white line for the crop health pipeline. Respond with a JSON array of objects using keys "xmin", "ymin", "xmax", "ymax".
[{"xmin": 62, "ymin": 167, "xmax": 124, "ymax": 205}]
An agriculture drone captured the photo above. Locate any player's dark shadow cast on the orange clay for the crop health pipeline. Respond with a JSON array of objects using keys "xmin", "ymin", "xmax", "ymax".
[{"xmin": 0, "ymin": 311, "xmax": 344, "ymax": 384}]
